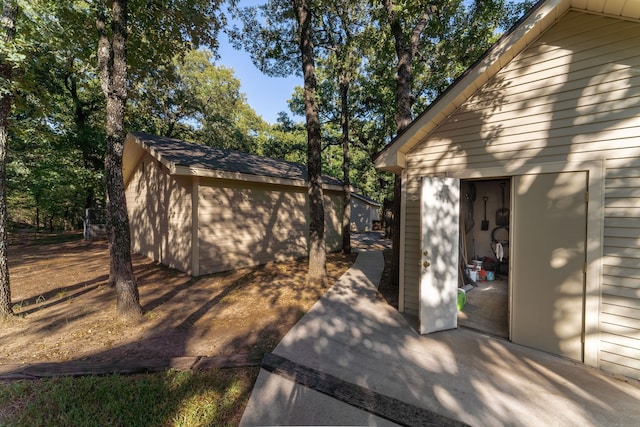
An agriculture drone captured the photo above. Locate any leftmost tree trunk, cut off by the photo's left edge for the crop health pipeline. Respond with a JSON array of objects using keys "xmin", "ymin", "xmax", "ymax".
[{"xmin": 0, "ymin": 0, "xmax": 18, "ymax": 317}]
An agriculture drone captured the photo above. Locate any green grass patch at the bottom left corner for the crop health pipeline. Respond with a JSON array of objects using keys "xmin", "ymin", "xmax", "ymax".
[{"xmin": 0, "ymin": 368, "xmax": 258, "ymax": 427}]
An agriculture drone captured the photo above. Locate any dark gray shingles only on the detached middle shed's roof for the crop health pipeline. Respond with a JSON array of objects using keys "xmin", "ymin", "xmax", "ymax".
[{"xmin": 130, "ymin": 132, "xmax": 342, "ymax": 186}]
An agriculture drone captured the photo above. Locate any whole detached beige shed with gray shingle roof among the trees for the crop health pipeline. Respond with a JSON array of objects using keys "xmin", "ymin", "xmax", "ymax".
[{"xmin": 123, "ymin": 132, "xmax": 344, "ymax": 276}]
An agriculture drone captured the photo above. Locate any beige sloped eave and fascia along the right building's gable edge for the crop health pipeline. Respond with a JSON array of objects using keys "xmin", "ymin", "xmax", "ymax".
[{"xmin": 375, "ymin": 0, "xmax": 640, "ymax": 173}]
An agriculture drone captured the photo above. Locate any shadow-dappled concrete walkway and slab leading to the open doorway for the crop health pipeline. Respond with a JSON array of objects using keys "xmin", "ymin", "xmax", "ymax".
[{"xmin": 241, "ymin": 251, "xmax": 640, "ymax": 426}]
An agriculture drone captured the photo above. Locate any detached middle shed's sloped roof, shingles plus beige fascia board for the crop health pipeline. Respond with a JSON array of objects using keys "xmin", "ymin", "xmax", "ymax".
[{"xmin": 124, "ymin": 132, "xmax": 343, "ymax": 189}]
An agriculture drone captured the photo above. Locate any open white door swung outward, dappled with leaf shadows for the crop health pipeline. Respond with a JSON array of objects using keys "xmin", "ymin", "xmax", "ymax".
[{"xmin": 419, "ymin": 177, "xmax": 460, "ymax": 334}]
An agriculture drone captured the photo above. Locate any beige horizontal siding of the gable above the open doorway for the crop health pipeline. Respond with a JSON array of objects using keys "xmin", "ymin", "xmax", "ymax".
[{"xmin": 407, "ymin": 12, "xmax": 640, "ymax": 174}]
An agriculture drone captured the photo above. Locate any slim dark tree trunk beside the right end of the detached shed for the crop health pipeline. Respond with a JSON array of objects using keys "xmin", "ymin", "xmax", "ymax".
[{"xmin": 340, "ymin": 78, "xmax": 351, "ymax": 254}]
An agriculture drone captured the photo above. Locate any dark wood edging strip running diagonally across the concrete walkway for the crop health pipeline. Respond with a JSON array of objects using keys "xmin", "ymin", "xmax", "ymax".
[{"xmin": 260, "ymin": 353, "xmax": 467, "ymax": 427}]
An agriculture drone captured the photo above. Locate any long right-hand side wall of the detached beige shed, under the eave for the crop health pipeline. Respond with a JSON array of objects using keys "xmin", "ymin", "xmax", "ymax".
[{"xmin": 198, "ymin": 180, "xmax": 342, "ymax": 274}]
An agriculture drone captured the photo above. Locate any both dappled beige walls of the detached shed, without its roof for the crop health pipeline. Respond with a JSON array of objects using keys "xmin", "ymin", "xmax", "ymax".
[{"xmin": 127, "ymin": 154, "xmax": 342, "ymax": 274}]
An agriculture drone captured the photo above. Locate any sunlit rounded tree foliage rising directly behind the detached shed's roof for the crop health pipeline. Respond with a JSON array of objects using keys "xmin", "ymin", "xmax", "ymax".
[{"xmin": 129, "ymin": 49, "xmax": 267, "ymax": 151}]
